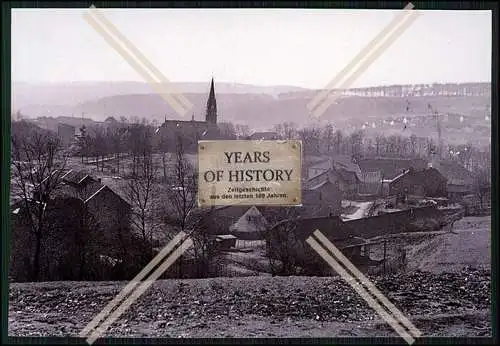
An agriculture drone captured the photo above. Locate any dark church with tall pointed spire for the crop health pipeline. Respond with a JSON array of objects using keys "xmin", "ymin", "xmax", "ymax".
[{"xmin": 156, "ymin": 78, "xmax": 232, "ymax": 152}]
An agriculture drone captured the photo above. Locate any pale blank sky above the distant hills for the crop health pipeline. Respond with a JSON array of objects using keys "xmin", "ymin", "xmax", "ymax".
[{"xmin": 11, "ymin": 9, "xmax": 492, "ymax": 88}]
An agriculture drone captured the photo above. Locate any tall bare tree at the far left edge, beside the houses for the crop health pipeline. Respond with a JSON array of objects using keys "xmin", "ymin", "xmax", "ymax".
[{"xmin": 11, "ymin": 132, "xmax": 66, "ymax": 281}]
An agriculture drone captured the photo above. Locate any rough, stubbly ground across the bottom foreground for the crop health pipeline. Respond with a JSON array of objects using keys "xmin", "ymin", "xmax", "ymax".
[{"xmin": 9, "ymin": 269, "xmax": 491, "ymax": 337}]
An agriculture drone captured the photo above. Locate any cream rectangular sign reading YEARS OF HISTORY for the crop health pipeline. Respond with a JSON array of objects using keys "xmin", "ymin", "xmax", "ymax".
[{"xmin": 198, "ymin": 140, "xmax": 302, "ymax": 207}]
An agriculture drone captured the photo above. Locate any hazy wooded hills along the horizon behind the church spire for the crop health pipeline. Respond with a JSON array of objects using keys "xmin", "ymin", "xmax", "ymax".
[{"xmin": 13, "ymin": 82, "xmax": 491, "ymax": 142}]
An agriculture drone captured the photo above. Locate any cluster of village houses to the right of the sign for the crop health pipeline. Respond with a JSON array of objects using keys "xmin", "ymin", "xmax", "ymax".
[{"xmin": 305, "ymin": 156, "xmax": 484, "ymax": 201}]
